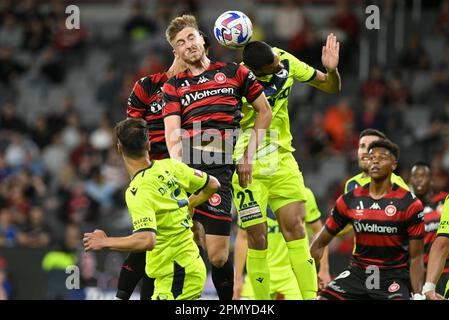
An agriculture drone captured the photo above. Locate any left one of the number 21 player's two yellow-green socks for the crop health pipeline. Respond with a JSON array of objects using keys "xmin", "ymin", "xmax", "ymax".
[{"xmin": 246, "ymin": 248, "xmax": 271, "ymax": 300}]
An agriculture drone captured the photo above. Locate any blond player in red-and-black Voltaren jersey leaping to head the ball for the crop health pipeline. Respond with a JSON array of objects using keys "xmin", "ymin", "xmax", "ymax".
[{"xmin": 163, "ymin": 15, "xmax": 271, "ymax": 300}]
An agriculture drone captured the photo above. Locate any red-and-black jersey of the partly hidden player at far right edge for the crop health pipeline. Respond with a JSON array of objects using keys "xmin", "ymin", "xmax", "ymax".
[{"xmin": 423, "ymin": 192, "xmax": 449, "ymax": 273}]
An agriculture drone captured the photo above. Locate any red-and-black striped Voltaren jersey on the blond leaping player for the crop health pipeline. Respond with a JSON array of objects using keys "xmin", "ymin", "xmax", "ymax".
[{"xmin": 162, "ymin": 62, "xmax": 263, "ymax": 148}]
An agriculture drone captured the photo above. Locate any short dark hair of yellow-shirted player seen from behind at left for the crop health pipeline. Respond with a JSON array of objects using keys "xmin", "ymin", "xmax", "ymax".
[{"xmin": 115, "ymin": 118, "xmax": 148, "ymax": 159}]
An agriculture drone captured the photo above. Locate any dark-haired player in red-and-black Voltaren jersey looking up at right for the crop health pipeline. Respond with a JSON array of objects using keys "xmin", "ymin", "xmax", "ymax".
[{"xmin": 310, "ymin": 139, "xmax": 424, "ymax": 300}]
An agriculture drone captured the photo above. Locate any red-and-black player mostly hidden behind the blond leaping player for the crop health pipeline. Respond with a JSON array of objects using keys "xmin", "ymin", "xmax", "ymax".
[{"xmin": 116, "ymin": 33, "xmax": 210, "ymax": 300}]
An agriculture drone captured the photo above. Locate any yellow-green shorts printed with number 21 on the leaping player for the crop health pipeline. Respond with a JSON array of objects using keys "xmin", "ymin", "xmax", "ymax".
[{"xmin": 232, "ymin": 151, "xmax": 305, "ymax": 228}]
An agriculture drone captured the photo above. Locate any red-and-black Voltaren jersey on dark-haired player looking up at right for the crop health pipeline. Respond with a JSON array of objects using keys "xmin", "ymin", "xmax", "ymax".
[{"xmin": 325, "ymin": 184, "xmax": 424, "ymax": 268}]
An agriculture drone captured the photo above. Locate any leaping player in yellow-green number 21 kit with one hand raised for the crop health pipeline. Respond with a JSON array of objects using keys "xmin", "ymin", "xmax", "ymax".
[{"xmin": 233, "ymin": 34, "xmax": 341, "ymax": 300}]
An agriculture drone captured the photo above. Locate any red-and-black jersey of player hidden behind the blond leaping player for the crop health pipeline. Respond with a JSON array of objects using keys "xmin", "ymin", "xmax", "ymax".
[{"xmin": 126, "ymin": 72, "xmax": 169, "ymax": 160}]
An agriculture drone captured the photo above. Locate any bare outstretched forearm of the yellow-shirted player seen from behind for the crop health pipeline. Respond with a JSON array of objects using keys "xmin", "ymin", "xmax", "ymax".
[{"xmin": 102, "ymin": 233, "xmax": 156, "ymax": 252}]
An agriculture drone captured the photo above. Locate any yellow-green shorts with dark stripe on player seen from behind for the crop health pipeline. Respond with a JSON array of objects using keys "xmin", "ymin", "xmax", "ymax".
[{"xmin": 151, "ymin": 256, "xmax": 206, "ymax": 300}]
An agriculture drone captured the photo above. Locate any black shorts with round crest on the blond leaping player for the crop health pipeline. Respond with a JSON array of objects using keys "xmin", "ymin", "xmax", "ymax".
[{"xmin": 193, "ymin": 164, "xmax": 235, "ymax": 236}]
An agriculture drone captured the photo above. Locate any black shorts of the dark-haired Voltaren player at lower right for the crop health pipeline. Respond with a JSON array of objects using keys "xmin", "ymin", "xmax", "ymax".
[{"xmin": 319, "ymin": 265, "xmax": 411, "ymax": 300}]
